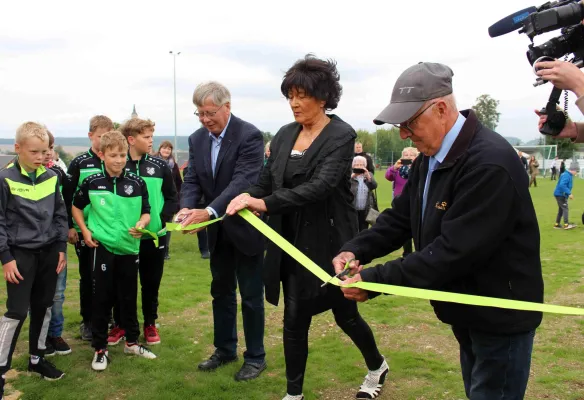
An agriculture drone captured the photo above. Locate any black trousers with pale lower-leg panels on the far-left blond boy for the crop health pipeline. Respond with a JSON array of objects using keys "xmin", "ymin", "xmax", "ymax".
[{"xmin": 0, "ymin": 245, "xmax": 59, "ymax": 375}]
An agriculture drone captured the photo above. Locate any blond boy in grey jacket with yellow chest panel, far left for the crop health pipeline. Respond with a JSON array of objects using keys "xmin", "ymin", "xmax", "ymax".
[{"xmin": 0, "ymin": 122, "xmax": 67, "ymax": 397}]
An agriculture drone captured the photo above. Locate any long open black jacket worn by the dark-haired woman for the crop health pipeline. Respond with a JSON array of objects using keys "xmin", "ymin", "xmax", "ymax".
[{"xmin": 246, "ymin": 115, "xmax": 357, "ymax": 305}]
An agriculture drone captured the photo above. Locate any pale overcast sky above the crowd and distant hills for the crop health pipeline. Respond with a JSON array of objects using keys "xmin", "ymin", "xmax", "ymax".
[{"xmin": 0, "ymin": 0, "xmax": 582, "ymax": 145}]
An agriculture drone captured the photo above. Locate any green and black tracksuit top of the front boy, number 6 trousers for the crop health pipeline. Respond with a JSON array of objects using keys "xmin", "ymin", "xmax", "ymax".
[{"xmin": 73, "ymin": 169, "xmax": 150, "ymax": 255}]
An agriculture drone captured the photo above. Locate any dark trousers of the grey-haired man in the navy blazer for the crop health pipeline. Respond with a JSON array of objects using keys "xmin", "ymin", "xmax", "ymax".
[{"xmin": 210, "ymin": 230, "xmax": 266, "ymax": 364}]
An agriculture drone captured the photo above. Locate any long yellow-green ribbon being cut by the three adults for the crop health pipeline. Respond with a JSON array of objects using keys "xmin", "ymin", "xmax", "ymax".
[{"xmin": 166, "ymin": 209, "xmax": 584, "ymax": 315}]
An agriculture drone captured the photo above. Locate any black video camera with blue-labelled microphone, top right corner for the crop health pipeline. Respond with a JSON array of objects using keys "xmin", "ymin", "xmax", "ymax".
[{"xmin": 489, "ymin": 0, "xmax": 584, "ymax": 136}]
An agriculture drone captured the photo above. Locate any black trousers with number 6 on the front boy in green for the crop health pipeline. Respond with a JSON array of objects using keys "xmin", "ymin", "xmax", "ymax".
[{"xmin": 91, "ymin": 245, "xmax": 140, "ymax": 350}]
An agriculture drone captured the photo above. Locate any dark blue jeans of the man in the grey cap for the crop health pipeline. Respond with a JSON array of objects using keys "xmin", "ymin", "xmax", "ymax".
[{"xmin": 452, "ymin": 327, "xmax": 535, "ymax": 400}]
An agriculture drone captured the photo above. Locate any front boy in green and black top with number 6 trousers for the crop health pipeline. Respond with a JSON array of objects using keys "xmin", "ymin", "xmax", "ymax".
[{"xmin": 71, "ymin": 131, "xmax": 156, "ymax": 371}]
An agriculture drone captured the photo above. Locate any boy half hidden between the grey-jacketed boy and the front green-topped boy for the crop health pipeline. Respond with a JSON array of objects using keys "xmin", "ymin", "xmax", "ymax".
[{"xmin": 65, "ymin": 115, "xmax": 114, "ymax": 341}]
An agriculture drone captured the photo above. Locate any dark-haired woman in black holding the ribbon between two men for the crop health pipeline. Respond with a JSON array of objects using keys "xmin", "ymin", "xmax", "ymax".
[{"xmin": 227, "ymin": 55, "xmax": 389, "ymax": 400}]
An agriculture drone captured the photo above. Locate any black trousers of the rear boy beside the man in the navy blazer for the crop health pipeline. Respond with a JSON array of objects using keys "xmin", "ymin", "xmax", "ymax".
[{"xmin": 139, "ymin": 236, "xmax": 166, "ymax": 325}]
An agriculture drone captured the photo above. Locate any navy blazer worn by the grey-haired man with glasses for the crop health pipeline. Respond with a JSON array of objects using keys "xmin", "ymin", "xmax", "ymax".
[{"xmin": 180, "ymin": 114, "xmax": 264, "ymax": 256}]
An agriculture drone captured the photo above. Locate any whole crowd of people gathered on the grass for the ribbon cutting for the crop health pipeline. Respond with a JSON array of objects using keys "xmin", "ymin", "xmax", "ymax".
[{"xmin": 0, "ymin": 51, "xmax": 579, "ymax": 400}]
